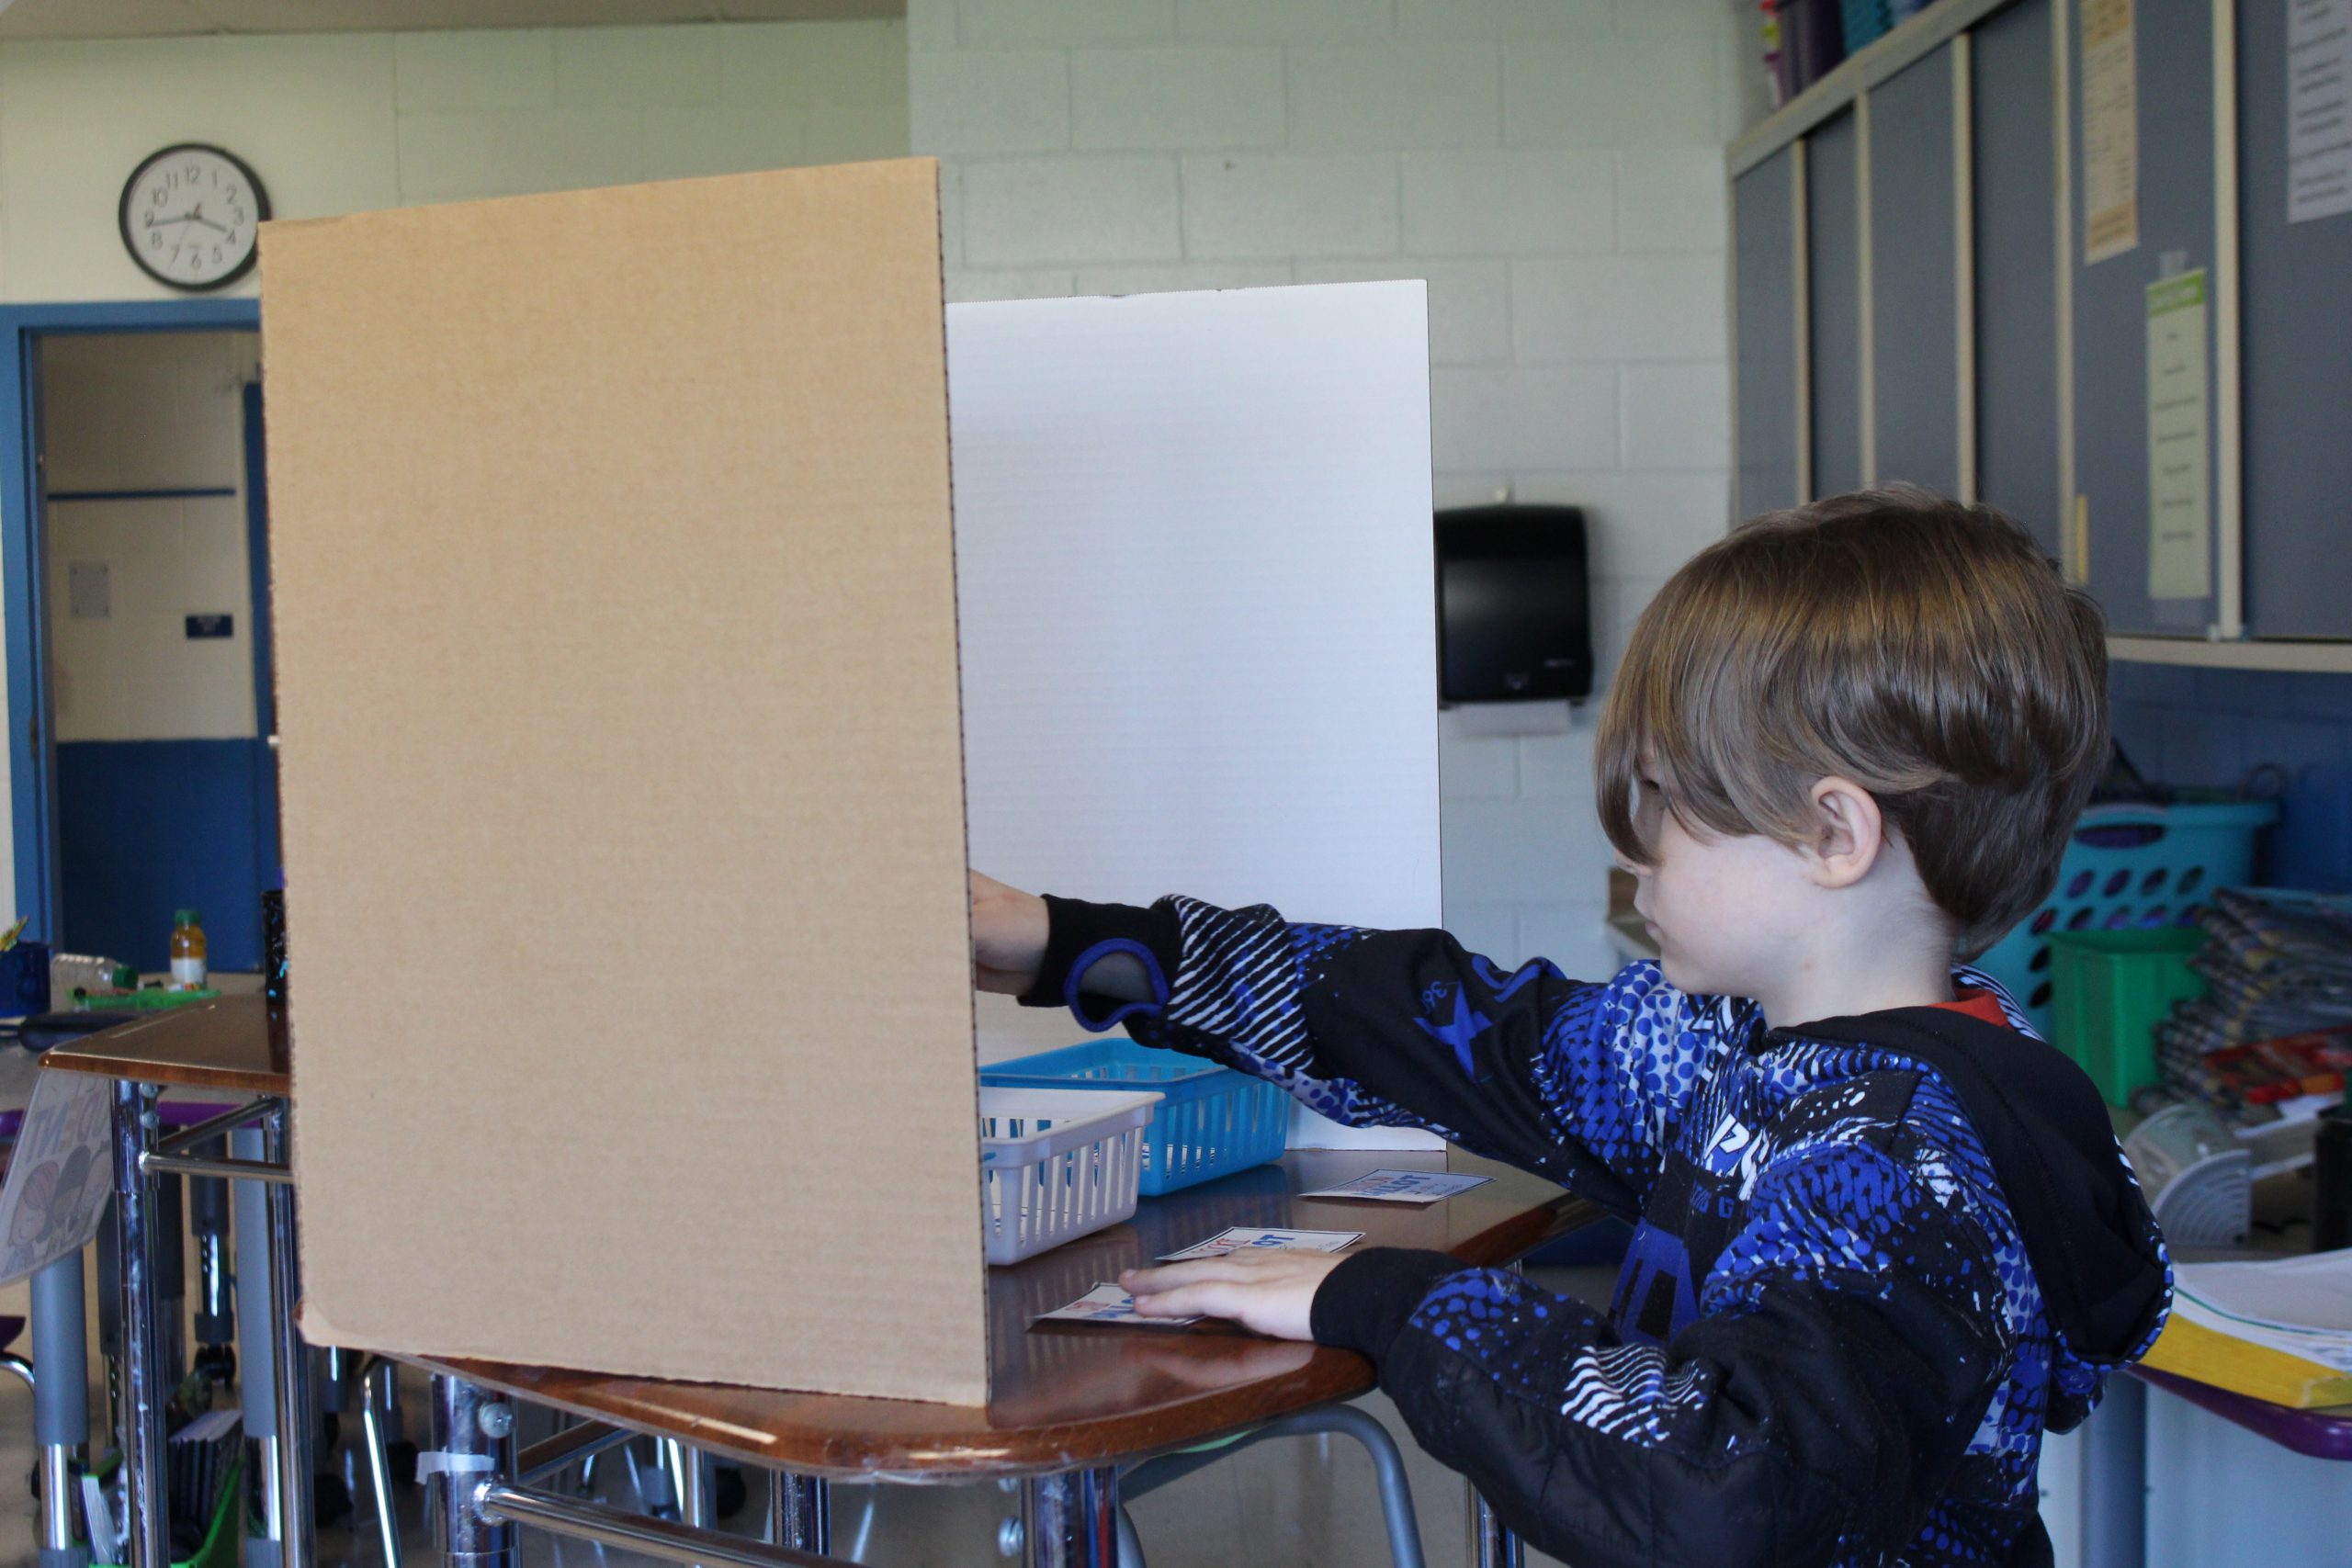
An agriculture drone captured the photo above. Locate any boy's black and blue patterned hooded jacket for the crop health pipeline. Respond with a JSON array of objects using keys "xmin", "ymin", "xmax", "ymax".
[{"xmin": 1023, "ymin": 898, "xmax": 2171, "ymax": 1568}]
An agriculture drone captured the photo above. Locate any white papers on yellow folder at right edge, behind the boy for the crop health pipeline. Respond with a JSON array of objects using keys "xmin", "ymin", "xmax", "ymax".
[{"xmin": 2147, "ymin": 1248, "xmax": 2352, "ymax": 1408}]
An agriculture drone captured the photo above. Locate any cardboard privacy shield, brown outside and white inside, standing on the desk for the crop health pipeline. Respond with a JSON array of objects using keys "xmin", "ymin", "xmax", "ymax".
[{"xmin": 261, "ymin": 160, "xmax": 1437, "ymax": 1404}]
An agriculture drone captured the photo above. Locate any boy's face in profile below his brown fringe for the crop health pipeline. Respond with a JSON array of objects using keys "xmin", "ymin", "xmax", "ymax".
[{"xmin": 1621, "ymin": 769, "xmax": 1815, "ymax": 997}]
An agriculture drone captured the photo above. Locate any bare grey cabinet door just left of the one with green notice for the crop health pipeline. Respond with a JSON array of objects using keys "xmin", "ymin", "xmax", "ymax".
[{"xmin": 1969, "ymin": 0, "xmax": 2061, "ymax": 555}]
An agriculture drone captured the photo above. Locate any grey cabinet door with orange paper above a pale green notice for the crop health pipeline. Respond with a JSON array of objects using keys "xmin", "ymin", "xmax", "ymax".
[{"xmin": 2065, "ymin": 0, "xmax": 2218, "ymax": 635}]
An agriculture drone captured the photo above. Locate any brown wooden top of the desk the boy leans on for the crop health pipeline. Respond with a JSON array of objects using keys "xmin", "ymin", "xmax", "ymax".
[{"xmin": 398, "ymin": 1152, "xmax": 1600, "ymax": 1481}]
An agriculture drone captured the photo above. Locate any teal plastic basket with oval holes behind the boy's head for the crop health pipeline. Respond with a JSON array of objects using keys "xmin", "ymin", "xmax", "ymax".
[{"xmin": 1975, "ymin": 799, "xmax": 2279, "ymax": 1037}]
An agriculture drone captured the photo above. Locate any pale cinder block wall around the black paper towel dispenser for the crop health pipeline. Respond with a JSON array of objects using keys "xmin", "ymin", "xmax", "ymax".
[{"xmin": 908, "ymin": 0, "xmax": 1755, "ymax": 974}]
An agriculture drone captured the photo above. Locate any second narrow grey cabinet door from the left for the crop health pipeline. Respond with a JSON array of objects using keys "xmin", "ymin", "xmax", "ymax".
[{"xmin": 1804, "ymin": 110, "xmax": 1863, "ymax": 496}]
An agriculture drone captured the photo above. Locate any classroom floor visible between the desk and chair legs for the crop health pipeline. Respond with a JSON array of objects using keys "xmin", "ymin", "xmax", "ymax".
[{"xmin": 0, "ymin": 1269, "xmax": 1613, "ymax": 1568}]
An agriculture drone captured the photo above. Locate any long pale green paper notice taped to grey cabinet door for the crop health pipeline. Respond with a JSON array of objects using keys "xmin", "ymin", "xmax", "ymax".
[{"xmin": 2147, "ymin": 268, "xmax": 2213, "ymax": 600}]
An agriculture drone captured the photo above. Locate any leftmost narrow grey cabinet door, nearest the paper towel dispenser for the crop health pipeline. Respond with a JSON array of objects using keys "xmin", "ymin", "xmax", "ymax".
[{"xmin": 1731, "ymin": 148, "xmax": 1804, "ymax": 517}]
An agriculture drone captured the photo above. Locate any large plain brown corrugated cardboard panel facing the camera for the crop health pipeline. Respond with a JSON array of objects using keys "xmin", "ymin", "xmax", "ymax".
[{"xmin": 261, "ymin": 160, "xmax": 988, "ymax": 1404}]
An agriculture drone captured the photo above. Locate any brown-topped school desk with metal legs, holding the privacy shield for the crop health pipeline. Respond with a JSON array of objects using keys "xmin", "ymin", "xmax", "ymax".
[{"xmin": 388, "ymin": 1152, "xmax": 1600, "ymax": 1568}]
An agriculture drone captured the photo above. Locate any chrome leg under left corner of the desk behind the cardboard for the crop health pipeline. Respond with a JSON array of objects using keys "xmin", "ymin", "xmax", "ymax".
[{"xmin": 115, "ymin": 1084, "xmax": 172, "ymax": 1568}]
